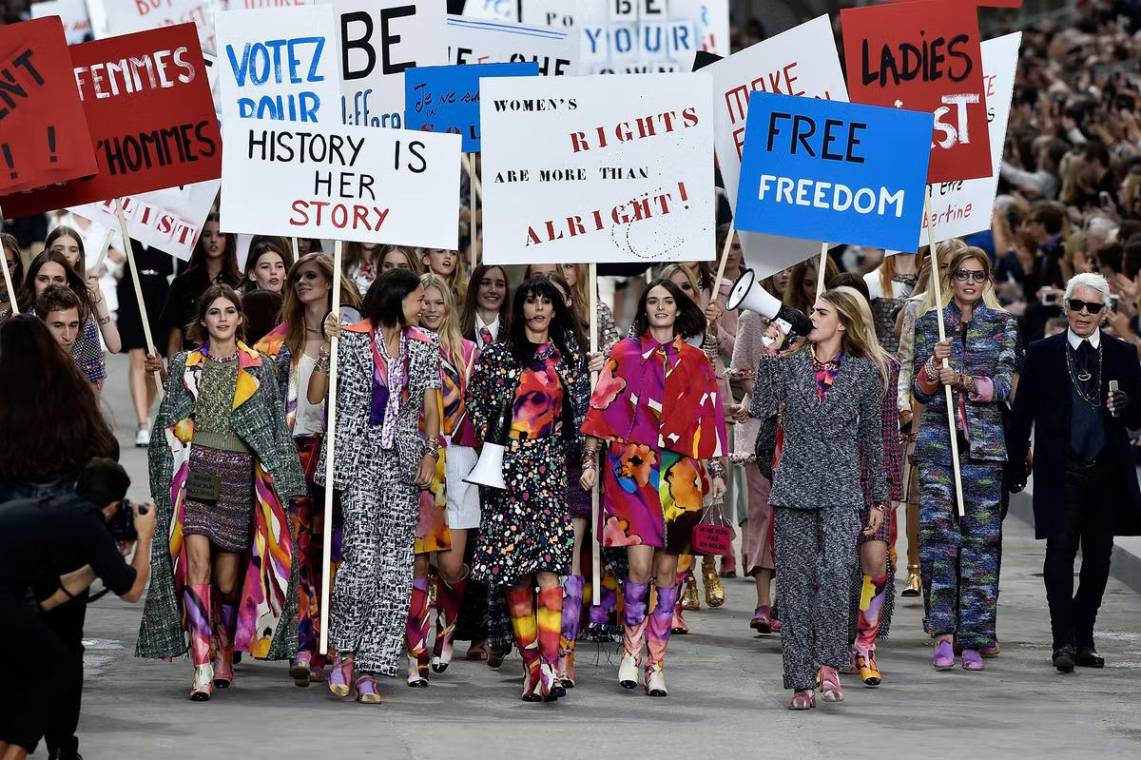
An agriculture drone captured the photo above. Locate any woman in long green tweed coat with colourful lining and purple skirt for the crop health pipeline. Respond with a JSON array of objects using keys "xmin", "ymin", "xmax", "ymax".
[{"xmin": 136, "ymin": 285, "xmax": 305, "ymax": 702}]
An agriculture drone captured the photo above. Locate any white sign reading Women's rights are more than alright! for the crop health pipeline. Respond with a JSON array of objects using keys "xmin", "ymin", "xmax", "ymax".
[{"xmin": 479, "ymin": 73, "xmax": 715, "ymax": 264}]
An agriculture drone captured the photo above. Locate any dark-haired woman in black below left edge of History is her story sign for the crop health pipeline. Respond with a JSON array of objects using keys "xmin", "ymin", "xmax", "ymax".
[{"xmin": 155, "ymin": 213, "xmax": 242, "ymax": 357}]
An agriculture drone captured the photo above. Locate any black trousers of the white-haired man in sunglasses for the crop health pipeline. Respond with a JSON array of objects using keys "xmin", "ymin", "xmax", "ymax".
[{"xmin": 1043, "ymin": 454, "xmax": 1118, "ymax": 649}]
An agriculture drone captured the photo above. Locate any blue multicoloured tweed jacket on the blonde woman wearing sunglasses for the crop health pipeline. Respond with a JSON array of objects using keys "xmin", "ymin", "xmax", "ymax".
[{"xmin": 912, "ymin": 301, "xmax": 1019, "ymax": 464}]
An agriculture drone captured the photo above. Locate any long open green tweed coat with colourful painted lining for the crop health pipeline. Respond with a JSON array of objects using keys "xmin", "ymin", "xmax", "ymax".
[{"xmin": 136, "ymin": 343, "xmax": 306, "ymax": 660}]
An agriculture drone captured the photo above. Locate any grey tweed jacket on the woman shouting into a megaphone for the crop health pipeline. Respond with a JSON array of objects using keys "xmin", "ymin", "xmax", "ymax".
[{"xmin": 751, "ymin": 348, "xmax": 888, "ymax": 509}]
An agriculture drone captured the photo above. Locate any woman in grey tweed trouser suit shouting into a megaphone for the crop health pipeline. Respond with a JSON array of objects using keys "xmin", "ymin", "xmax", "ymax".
[{"xmin": 751, "ymin": 288, "xmax": 890, "ymax": 710}]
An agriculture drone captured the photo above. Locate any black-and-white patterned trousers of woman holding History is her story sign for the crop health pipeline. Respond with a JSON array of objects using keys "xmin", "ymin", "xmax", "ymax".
[{"xmin": 329, "ymin": 452, "xmax": 420, "ymax": 676}]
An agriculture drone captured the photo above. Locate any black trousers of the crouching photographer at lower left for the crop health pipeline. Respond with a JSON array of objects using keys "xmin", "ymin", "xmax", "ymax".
[{"xmin": 43, "ymin": 591, "xmax": 87, "ymax": 759}]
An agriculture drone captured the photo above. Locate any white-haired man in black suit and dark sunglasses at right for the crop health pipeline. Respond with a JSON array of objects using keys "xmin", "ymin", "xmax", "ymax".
[{"xmin": 1006, "ymin": 274, "xmax": 1141, "ymax": 673}]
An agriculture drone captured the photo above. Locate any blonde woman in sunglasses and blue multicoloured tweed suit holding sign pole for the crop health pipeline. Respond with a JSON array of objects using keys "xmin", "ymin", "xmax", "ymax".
[{"xmin": 913, "ymin": 248, "xmax": 1019, "ymax": 670}]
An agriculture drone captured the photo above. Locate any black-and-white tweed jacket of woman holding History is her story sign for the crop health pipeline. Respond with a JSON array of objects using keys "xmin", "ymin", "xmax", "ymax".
[{"xmin": 315, "ymin": 321, "xmax": 440, "ymax": 491}]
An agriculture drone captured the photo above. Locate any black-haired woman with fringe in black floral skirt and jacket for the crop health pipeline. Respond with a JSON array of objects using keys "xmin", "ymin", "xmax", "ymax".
[{"xmin": 466, "ymin": 277, "xmax": 589, "ymax": 702}]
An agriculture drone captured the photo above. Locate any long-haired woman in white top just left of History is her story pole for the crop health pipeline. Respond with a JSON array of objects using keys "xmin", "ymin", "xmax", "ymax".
[{"xmin": 254, "ymin": 253, "xmax": 361, "ymax": 687}]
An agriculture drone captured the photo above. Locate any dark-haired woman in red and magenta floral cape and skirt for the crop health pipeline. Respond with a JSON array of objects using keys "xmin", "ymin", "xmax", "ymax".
[{"xmin": 582, "ymin": 280, "xmax": 728, "ymax": 696}]
